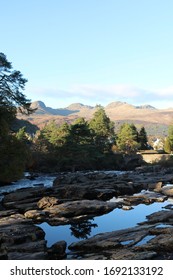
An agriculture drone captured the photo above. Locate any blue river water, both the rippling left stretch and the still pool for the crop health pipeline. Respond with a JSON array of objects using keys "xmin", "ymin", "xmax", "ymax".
[{"xmin": 0, "ymin": 173, "xmax": 173, "ymax": 250}]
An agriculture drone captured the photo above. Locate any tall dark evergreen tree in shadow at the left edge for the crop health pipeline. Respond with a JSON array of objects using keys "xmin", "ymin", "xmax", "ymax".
[{"xmin": 0, "ymin": 53, "xmax": 33, "ymax": 183}]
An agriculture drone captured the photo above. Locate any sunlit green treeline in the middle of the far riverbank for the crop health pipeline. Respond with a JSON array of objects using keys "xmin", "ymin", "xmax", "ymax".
[{"xmin": 27, "ymin": 106, "xmax": 148, "ymax": 171}]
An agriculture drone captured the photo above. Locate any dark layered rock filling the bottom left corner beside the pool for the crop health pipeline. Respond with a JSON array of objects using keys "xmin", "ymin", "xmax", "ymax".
[{"xmin": 0, "ymin": 214, "xmax": 47, "ymax": 260}]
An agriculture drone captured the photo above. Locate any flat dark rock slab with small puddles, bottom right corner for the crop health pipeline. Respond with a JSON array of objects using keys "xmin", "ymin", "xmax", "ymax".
[{"xmin": 69, "ymin": 209, "xmax": 173, "ymax": 260}]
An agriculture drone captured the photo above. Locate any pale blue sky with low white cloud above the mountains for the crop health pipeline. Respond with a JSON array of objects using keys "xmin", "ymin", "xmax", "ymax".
[{"xmin": 0, "ymin": 0, "xmax": 173, "ymax": 108}]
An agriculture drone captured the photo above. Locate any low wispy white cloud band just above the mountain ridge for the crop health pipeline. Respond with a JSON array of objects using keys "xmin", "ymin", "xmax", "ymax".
[{"xmin": 27, "ymin": 84, "xmax": 173, "ymax": 107}]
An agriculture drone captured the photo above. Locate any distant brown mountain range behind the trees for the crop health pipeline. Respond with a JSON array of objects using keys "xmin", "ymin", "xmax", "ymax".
[{"xmin": 18, "ymin": 101, "xmax": 173, "ymax": 136}]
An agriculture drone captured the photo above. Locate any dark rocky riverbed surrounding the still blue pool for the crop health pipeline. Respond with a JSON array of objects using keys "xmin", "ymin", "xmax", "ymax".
[{"xmin": 0, "ymin": 166, "xmax": 173, "ymax": 259}]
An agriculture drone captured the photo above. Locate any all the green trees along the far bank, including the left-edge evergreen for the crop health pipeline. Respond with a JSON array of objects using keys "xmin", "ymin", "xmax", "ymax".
[{"xmin": 0, "ymin": 53, "xmax": 173, "ymax": 184}]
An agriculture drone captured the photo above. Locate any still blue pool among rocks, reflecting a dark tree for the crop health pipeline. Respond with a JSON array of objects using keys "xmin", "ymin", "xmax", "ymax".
[{"xmin": 38, "ymin": 200, "xmax": 172, "ymax": 247}]
